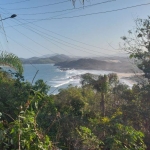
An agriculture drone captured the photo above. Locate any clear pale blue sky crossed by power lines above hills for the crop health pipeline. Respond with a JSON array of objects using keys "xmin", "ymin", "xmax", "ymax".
[{"xmin": 0, "ymin": 0, "xmax": 150, "ymax": 58}]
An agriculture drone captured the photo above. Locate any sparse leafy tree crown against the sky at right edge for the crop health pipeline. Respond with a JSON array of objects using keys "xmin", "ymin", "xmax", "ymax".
[{"xmin": 122, "ymin": 17, "xmax": 150, "ymax": 80}]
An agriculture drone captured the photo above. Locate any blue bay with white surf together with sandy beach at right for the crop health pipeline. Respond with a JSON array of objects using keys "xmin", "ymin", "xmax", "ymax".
[{"xmin": 24, "ymin": 64, "xmax": 141, "ymax": 94}]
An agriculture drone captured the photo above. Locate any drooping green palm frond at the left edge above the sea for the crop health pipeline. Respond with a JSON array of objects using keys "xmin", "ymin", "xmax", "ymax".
[{"xmin": 0, "ymin": 51, "xmax": 23, "ymax": 74}]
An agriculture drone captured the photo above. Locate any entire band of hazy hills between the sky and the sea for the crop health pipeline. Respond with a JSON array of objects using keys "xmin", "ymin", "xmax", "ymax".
[{"xmin": 21, "ymin": 54, "xmax": 141, "ymax": 73}]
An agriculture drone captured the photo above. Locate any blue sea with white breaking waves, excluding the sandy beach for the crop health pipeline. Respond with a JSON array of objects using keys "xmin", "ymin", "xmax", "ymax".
[{"xmin": 24, "ymin": 64, "xmax": 116, "ymax": 94}]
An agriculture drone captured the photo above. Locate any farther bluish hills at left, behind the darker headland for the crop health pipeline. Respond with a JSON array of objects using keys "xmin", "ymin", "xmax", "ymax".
[{"xmin": 20, "ymin": 54, "xmax": 73, "ymax": 64}]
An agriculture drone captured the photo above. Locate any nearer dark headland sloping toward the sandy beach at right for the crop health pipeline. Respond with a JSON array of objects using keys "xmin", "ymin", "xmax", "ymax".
[{"xmin": 55, "ymin": 58, "xmax": 141, "ymax": 73}]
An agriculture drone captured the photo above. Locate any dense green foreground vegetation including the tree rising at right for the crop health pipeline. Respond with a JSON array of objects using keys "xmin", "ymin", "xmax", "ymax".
[{"xmin": 0, "ymin": 16, "xmax": 150, "ymax": 150}]
